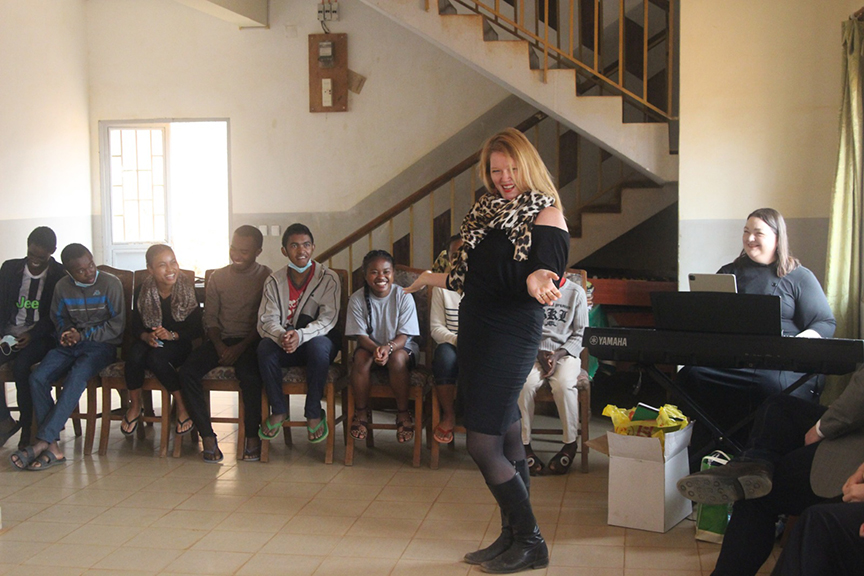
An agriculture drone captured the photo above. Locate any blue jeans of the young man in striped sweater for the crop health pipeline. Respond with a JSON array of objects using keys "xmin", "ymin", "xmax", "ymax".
[{"xmin": 30, "ymin": 340, "xmax": 117, "ymax": 442}]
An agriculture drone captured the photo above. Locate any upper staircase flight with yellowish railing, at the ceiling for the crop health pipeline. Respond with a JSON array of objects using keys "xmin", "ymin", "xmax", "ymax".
[{"xmin": 361, "ymin": 0, "xmax": 678, "ymax": 182}]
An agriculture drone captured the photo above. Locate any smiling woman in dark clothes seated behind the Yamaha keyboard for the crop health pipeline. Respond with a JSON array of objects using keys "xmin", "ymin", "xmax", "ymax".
[{"xmin": 678, "ymin": 208, "xmax": 835, "ymax": 447}]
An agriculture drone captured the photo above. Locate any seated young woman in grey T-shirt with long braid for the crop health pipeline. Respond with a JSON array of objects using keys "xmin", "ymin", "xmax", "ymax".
[{"xmin": 345, "ymin": 250, "xmax": 420, "ymax": 442}]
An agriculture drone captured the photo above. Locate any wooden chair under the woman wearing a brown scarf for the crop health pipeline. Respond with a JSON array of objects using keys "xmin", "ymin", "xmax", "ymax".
[{"xmin": 99, "ymin": 270, "xmax": 195, "ymax": 458}]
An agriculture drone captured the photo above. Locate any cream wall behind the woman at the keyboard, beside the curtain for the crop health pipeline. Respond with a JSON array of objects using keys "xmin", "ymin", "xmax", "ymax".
[{"xmin": 679, "ymin": 0, "xmax": 860, "ymax": 284}]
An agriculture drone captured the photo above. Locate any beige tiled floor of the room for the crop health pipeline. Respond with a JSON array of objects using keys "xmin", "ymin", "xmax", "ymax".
[{"xmin": 0, "ymin": 395, "xmax": 776, "ymax": 576}]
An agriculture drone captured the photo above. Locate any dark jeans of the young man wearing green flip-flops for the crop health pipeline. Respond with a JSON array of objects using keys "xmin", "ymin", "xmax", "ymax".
[{"xmin": 258, "ymin": 336, "xmax": 339, "ymax": 420}]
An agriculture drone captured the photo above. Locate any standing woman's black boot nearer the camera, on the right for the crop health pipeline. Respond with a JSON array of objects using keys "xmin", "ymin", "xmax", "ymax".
[{"xmin": 480, "ymin": 474, "xmax": 549, "ymax": 574}]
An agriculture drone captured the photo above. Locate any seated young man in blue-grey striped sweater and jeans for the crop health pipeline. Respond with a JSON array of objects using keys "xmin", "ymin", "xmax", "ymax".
[{"xmin": 10, "ymin": 244, "xmax": 126, "ymax": 470}]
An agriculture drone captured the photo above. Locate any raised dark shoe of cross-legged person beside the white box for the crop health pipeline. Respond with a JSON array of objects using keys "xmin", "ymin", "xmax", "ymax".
[{"xmin": 678, "ymin": 458, "xmax": 774, "ymax": 505}]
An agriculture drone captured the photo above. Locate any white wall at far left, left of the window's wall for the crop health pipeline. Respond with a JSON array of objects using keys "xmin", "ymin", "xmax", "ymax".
[{"xmin": 0, "ymin": 0, "xmax": 92, "ymax": 261}]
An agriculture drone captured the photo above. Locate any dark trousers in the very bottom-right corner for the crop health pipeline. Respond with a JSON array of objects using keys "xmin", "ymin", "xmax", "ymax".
[{"xmin": 771, "ymin": 502, "xmax": 864, "ymax": 576}]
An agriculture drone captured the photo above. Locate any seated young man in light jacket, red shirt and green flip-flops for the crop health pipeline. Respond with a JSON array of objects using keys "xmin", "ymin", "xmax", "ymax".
[{"xmin": 258, "ymin": 224, "xmax": 342, "ymax": 443}]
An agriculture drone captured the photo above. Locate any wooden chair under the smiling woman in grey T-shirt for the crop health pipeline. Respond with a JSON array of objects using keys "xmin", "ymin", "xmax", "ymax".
[{"xmin": 343, "ymin": 265, "xmax": 432, "ymax": 468}]
